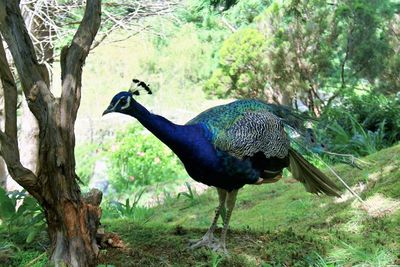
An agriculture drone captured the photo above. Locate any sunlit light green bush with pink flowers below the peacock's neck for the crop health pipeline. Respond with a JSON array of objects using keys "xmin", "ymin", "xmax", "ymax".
[{"xmin": 107, "ymin": 124, "xmax": 186, "ymax": 193}]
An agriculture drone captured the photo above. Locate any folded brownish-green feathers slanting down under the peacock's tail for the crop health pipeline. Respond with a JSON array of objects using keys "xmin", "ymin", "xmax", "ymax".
[{"xmin": 289, "ymin": 148, "xmax": 340, "ymax": 197}]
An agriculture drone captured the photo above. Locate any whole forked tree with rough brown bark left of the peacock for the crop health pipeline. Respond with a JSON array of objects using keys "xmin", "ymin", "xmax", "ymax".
[{"xmin": 0, "ymin": 0, "xmax": 101, "ymax": 266}]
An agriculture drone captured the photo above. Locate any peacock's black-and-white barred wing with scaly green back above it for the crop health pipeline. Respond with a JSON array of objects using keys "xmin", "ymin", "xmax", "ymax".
[{"xmin": 188, "ymin": 100, "xmax": 290, "ymax": 159}]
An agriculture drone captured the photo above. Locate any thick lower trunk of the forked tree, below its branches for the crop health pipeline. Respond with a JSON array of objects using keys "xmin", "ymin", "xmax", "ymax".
[{"xmin": 34, "ymin": 101, "xmax": 101, "ymax": 266}]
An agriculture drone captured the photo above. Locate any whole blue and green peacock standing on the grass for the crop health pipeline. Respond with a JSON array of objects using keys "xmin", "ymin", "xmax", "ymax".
[{"xmin": 103, "ymin": 80, "xmax": 339, "ymax": 252}]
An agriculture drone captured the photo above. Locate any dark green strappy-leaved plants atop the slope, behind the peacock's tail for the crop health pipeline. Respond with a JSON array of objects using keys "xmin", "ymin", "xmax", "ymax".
[{"xmin": 318, "ymin": 94, "xmax": 400, "ymax": 156}]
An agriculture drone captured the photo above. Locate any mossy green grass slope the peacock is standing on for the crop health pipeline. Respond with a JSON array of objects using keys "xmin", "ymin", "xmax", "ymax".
[{"xmin": 94, "ymin": 145, "xmax": 400, "ymax": 266}]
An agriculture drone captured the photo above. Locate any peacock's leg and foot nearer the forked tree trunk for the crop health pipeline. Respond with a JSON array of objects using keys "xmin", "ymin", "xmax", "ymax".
[{"xmin": 190, "ymin": 188, "xmax": 227, "ymax": 249}]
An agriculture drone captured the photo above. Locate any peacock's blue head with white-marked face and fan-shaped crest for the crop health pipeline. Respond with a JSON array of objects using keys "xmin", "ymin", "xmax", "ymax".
[{"xmin": 103, "ymin": 79, "xmax": 152, "ymax": 116}]
